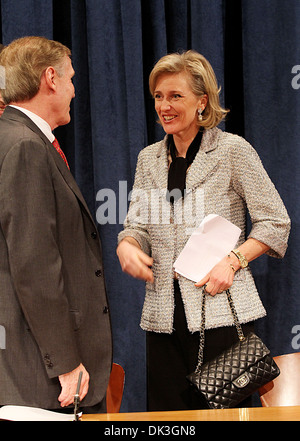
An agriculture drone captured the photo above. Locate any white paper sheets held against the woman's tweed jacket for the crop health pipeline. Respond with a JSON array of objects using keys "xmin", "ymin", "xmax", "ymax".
[{"xmin": 174, "ymin": 214, "xmax": 241, "ymax": 282}]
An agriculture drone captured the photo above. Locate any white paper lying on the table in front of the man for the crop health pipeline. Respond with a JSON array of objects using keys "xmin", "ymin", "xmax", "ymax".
[{"xmin": 0, "ymin": 405, "xmax": 79, "ymax": 421}]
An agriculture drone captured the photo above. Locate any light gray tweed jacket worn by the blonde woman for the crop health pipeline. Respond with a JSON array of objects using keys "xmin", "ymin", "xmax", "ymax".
[{"xmin": 118, "ymin": 128, "xmax": 290, "ymax": 333}]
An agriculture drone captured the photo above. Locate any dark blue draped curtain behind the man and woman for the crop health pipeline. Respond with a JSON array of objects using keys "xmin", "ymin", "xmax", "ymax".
[{"xmin": 0, "ymin": 0, "xmax": 300, "ymax": 411}]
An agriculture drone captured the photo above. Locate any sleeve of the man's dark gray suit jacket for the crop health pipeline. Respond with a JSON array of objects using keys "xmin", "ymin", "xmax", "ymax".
[{"xmin": 0, "ymin": 139, "xmax": 80, "ymax": 378}]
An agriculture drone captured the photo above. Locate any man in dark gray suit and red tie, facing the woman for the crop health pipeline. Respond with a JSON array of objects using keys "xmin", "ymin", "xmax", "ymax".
[{"xmin": 0, "ymin": 37, "xmax": 112, "ymax": 413}]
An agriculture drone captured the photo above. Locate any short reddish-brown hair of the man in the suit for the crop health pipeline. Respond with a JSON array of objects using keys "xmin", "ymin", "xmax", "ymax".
[{"xmin": 0, "ymin": 37, "xmax": 71, "ymax": 104}]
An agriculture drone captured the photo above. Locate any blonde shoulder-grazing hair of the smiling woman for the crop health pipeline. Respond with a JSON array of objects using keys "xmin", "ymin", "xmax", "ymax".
[{"xmin": 149, "ymin": 50, "xmax": 229, "ymax": 129}]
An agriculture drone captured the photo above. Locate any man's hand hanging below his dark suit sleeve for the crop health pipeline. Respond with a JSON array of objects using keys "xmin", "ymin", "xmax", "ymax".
[{"xmin": 58, "ymin": 364, "xmax": 90, "ymax": 407}]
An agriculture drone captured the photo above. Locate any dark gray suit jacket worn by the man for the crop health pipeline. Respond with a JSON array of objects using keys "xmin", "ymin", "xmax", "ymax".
[{"xmin": 0, "ymin": 107, "xmax": 112, "ymax": 409}]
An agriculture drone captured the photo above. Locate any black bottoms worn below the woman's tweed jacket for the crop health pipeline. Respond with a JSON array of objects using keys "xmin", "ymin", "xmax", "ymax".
[{"xmin": 147, "ymin": 280, "xmax": 254, "ymax": 411}]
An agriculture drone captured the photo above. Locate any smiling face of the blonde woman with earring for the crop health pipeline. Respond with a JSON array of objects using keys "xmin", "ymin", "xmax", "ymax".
[{"xmin": 154, "ymin": 72, "xmax": 206, "ymax": 139}]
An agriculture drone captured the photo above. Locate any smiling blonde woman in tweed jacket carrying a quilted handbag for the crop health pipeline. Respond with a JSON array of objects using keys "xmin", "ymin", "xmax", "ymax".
[{"xmin": 117, "ymin": 51, "xmax": 290, "ymax": 410}]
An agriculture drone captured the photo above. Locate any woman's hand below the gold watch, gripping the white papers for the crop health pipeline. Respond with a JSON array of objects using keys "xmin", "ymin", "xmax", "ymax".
[{"xmin": 195, "ymin": 256, "xmax": 234, "ymax": 296}]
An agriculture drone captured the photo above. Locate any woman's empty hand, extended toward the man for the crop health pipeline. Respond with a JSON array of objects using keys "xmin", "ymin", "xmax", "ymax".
[{"xmin": 117, "ymin": 237, "xmax": 154, "ymax": 283}]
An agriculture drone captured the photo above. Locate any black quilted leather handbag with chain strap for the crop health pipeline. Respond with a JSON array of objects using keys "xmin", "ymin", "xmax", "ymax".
[{"xmin": 187, "ymin": 289, "xmax": 280, "ymax": 409}]
